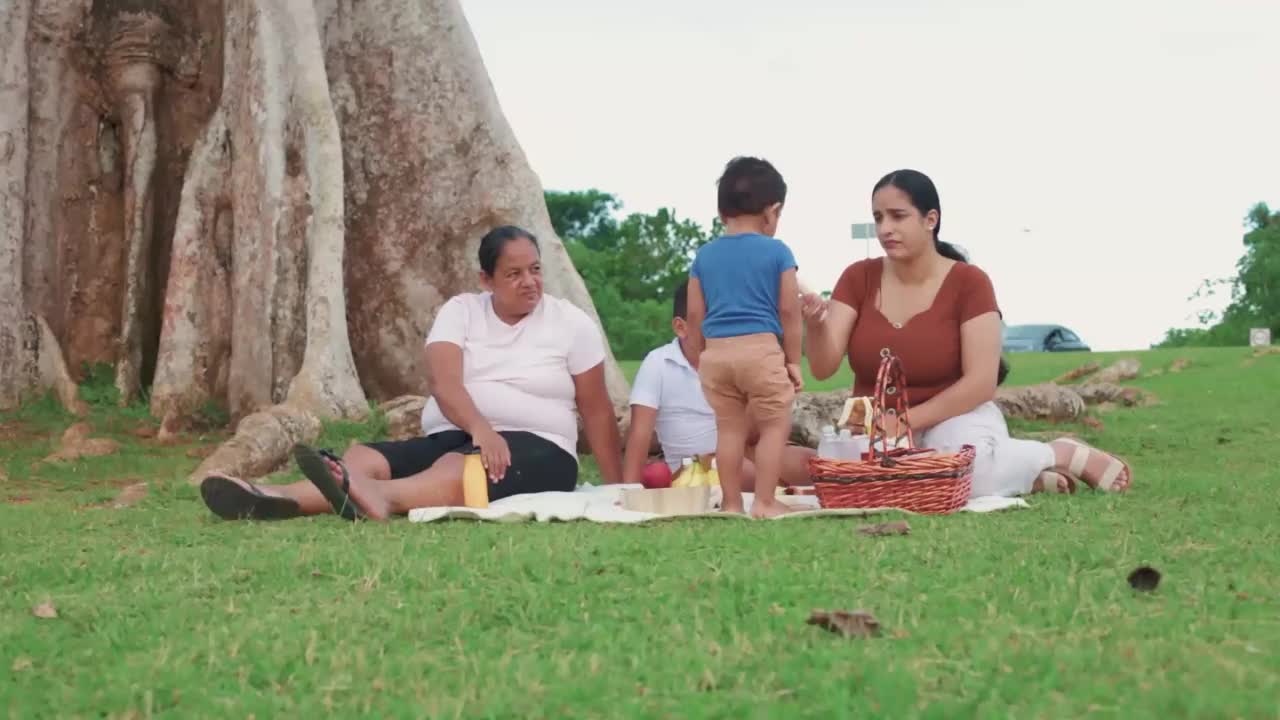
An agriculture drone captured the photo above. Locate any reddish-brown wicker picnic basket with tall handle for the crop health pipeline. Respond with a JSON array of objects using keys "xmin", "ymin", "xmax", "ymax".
[{"xmin": 809, "ymin": 350, "xmax": 975, "ymax": 515}]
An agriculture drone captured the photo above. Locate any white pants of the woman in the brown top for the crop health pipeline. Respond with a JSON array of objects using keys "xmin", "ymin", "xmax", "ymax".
[{"xmin": 915, "ymin": 402, "xmax": 1056, "ymax": 497}]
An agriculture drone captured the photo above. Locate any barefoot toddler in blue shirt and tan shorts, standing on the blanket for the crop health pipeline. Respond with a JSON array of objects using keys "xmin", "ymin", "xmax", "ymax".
[{"xmin": 689, "ymin": 158, "xmax": 804, "ymax": 518}]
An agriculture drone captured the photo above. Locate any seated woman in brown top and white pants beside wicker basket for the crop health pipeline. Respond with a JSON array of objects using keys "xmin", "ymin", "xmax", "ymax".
[{"xmin": 804, "ymin": 170, "xmax": 1133, "ymax": 497}]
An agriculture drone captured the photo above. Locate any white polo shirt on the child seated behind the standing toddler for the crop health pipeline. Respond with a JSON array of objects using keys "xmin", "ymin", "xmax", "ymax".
[{"xmin": 631, "ymin": 338, "xmax": 716, "ymax": 469}]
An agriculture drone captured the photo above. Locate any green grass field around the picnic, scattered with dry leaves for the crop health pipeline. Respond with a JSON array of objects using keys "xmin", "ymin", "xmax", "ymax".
[{"xmin": 0, "ymin": 348, "xmax": 1280, "ymax": 719}]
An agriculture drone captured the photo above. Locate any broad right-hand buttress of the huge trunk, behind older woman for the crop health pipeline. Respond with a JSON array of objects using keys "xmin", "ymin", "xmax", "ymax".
[{"xmin": 324, "ymin": 0, "xmax": 626, "ymax": 407}]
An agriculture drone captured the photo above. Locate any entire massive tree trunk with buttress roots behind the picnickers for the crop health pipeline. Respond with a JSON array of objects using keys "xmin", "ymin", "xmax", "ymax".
[{"xmin": 0, "ymin": 0, "xmax": 626, "ymax": 481}]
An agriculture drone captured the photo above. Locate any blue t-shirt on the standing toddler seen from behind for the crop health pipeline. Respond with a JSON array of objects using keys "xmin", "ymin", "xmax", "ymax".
[{"xmin": 689, "ymin": 233, "xmax": 796, "ymax": 337}]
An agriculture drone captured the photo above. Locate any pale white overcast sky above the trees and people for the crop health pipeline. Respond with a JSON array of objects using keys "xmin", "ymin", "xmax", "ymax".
[{"xmin": 462, "ymin": 0, "xmax": 1280, "ymax": 350}]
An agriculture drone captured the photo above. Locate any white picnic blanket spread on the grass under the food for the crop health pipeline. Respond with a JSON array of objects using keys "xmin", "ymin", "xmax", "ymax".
[{"xmin": 408, "ymin": 484, "xmax": 1030, "ymax": 524}]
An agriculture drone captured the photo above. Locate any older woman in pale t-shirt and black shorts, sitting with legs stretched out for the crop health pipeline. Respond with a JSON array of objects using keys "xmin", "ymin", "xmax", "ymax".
[{"xmin": 201, "ymin": 225, "xmax": 622, "ymax": 520}]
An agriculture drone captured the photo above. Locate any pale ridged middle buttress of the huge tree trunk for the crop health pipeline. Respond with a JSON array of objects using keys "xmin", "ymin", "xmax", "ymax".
[{"xmin": 151, "ymin": 0, "xmax": 369, "ymax": 430}]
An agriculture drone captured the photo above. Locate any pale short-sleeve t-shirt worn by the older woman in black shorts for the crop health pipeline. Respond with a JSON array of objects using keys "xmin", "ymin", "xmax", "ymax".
[{"xmin": 422, "ymin": 292, "xmax": 604, "ymax": 459}]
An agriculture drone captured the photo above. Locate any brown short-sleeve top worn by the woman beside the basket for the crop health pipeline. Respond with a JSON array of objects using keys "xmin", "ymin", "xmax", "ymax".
[{"xmin": 831, "ymin": 258, "xmax": 1000, "ymax": 405}]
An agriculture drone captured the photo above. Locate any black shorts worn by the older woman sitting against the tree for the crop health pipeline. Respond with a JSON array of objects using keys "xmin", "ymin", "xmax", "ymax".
[{"xmin": 364, "ymin": 430, "xmax": 577, "ymax": 501}]
